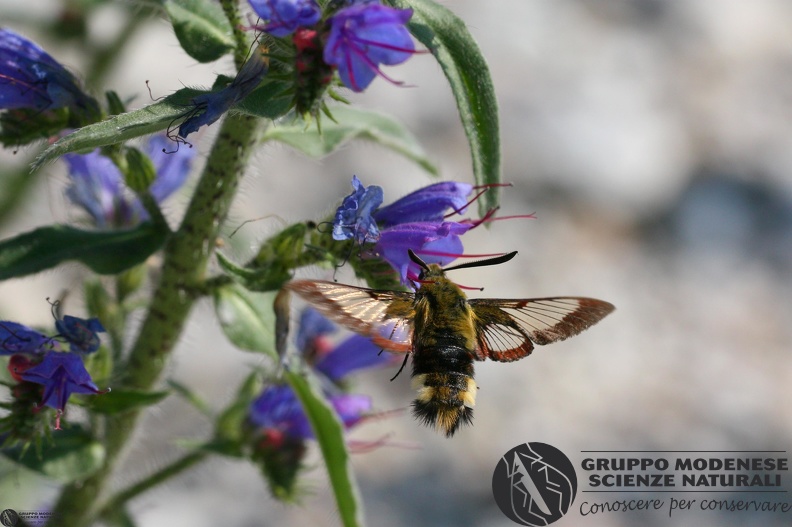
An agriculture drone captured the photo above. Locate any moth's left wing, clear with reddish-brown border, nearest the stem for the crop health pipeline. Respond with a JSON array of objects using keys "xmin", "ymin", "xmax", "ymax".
[{"xmin": 284, "ymin": 280, "xmax": 415, "ymax": 351}]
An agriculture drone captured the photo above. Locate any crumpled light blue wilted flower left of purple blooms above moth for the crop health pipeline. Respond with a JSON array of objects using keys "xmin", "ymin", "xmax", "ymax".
[{"xmin": 333, "ymin": 176, "xmax": 382, "ymax": 244}]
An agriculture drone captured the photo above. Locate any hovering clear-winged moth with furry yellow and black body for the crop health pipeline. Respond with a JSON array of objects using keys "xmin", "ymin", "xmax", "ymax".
[{"xmin": 276, "ymin": 251, "xmax": 614, "ymax": 437}]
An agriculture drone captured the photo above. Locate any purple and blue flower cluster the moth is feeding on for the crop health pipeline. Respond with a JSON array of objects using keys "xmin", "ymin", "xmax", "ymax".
[{"xmin": 333, "ymin": 176, "xmax": 510, "ymax": 285}]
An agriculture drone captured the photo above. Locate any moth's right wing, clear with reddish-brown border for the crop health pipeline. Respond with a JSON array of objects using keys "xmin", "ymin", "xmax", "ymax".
[{"xmin": 469, "ymin": 297, "xmax": 615, "ymax": 361}]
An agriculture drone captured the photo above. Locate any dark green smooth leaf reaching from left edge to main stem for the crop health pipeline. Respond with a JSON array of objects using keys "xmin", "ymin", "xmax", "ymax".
[{"xmin": 0, "ymin": 222, "xmax": 168, "ymax": 280}]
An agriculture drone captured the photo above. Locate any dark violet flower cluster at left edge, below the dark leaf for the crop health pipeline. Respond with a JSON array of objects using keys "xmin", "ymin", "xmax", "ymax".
[{"xmin": 0, "ymin": 315, "xmax": 107, "ymax": 430}]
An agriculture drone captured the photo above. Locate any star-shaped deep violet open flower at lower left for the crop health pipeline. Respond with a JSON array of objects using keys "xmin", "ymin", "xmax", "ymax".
[{"xmin": 21, "ymin": 351, "xmax": 102, "ymax": 422}]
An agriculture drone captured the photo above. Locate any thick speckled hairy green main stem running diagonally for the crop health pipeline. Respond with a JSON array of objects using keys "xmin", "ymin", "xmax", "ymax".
[{"xmin": 51, "ymin": 116, "xmax": 261, "ymax": 527}]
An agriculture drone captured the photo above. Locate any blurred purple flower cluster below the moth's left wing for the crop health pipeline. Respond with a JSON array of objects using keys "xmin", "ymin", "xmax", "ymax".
[{"xmin": 248, "ymin": 308, "xmax": 393, "ymax": 500}]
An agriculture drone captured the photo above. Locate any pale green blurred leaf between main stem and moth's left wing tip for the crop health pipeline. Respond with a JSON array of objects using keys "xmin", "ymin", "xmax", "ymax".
[{"xmin": 214, "ymin": 284, "xmax": 277, "ymax": 360}]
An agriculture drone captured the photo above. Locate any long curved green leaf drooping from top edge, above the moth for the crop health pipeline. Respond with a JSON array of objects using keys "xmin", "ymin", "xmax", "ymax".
[{"xmin": 388, "ymin": 0, "xmax": 501, "ymax": 216}]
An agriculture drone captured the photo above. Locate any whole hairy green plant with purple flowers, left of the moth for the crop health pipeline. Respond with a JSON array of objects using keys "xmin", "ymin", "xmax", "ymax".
[{"xmin": 0, "ymin": 0, "xmax": 500, "ymax": 527}]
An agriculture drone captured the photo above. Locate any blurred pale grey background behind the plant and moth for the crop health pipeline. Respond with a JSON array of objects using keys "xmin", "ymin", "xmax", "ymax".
[{"xmin": 0, "ymin": 0, "xmax": 792, "ymax": 527}]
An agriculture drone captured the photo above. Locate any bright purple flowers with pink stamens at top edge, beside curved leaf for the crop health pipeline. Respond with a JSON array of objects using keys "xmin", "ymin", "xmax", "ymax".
[{"xmin": 249, "ymin": 0, "xmax": 415, "ymax": 92}]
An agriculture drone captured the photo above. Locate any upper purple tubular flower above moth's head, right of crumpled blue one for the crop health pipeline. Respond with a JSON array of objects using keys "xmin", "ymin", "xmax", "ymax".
[{"xmin": 374, "ymin": 181, "xmax": 473, "ymax": 227}]
